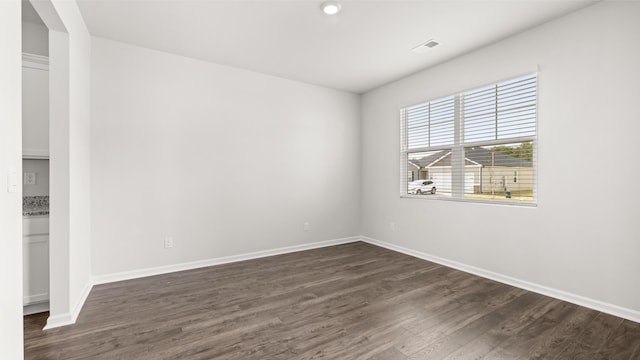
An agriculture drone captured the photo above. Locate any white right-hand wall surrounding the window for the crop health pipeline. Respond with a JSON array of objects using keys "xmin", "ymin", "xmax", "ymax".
[{"xmin": 362, "ymin": 2, "xmax": 640, "ymax": 318}]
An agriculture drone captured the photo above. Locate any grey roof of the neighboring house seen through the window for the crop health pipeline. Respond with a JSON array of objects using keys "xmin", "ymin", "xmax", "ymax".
[{"xmin": 409, "ymin": 147, "xmax": 533, "ymax": 168}]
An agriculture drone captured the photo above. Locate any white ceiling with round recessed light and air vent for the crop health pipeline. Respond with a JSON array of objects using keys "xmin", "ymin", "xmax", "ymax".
[{"xmin": 72, "ymin": 0, "xmax": 594, "ymax": 93}]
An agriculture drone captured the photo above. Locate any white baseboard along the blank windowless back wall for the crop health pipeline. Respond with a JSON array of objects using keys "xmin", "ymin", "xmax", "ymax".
[{"xmin": 92, "ymin": 236, "xmax": 361, "ymax": 285}]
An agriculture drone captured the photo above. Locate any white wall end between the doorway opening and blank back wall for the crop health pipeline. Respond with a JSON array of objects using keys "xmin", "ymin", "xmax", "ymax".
[{"xmin": 33, "ymin": 0, "xmax": 91, "ymax": 327}]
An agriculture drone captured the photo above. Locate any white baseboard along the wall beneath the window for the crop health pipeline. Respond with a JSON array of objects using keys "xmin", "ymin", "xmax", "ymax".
[{"xmin": 360, "ymin": 236, "xmax": 640, "ymax": 323}]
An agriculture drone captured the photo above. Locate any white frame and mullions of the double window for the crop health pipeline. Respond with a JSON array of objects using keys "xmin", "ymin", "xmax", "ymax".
[{"xmin": 399, "ymin": 70, "xmax": 539, "ymax": 207}]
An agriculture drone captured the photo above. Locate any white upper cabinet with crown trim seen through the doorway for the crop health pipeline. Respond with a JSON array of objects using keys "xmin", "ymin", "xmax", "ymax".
[{"xmin": 22, "ymin": 54, "xmax": 49, "ymax": 158}]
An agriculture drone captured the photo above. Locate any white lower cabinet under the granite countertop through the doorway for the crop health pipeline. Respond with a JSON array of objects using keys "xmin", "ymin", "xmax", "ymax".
[{"xmin": 22, "ymin": 215, "xmax": 49, "ymax": 312}]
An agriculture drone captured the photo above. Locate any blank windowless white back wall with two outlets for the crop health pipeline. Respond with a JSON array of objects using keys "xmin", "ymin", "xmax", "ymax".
[{"xmin": 91, "ymin": 37, "xmax": 360, "ymax": 276}]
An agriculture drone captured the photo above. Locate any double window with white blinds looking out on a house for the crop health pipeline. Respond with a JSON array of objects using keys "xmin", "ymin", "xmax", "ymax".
[{"xmin": 400, "ymin": 74, "xmax": 537, "ymax": 204}]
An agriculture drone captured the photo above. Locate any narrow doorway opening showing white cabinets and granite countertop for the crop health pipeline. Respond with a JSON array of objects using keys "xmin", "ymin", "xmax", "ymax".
[{"xmin": 22, "ymin": 1, "xmax": 50, "ymax": 315}]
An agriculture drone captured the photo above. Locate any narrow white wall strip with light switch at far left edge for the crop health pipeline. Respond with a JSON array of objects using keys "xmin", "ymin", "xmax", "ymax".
[{"xmin": 0, "ymin": 0, "xmax": 24, "ymax": 360}]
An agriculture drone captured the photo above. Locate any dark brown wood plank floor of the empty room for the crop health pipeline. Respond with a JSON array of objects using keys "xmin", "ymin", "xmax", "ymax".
[{"xmin": 25, "ymin": 243, "xmax": 640, "ymax": 360}]
